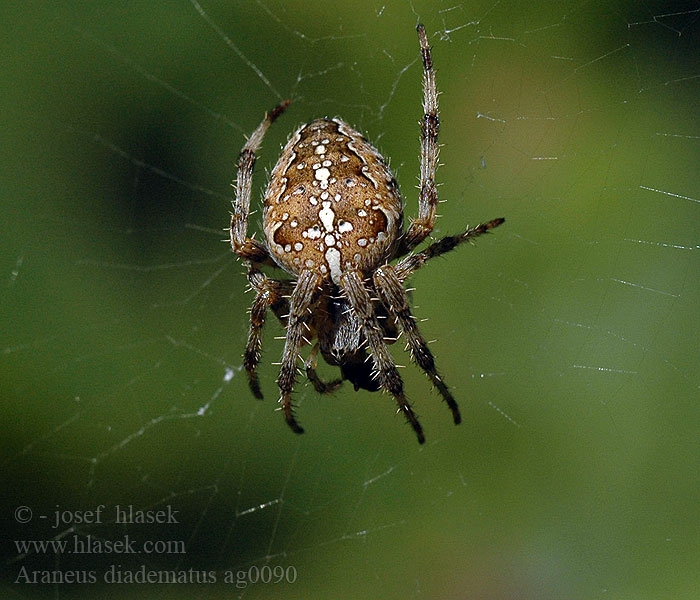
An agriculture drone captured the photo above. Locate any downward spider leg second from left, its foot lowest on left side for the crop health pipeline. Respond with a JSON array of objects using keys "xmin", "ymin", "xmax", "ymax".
[{"xmin": 277, "ymin": 270, "xmax": 323, "ymax": 433}]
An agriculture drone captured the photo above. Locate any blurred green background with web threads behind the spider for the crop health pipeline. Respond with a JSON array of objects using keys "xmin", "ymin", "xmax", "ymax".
[{"xmin": 0, "ymin": 0, "xmax": 700, "ymax": 599}]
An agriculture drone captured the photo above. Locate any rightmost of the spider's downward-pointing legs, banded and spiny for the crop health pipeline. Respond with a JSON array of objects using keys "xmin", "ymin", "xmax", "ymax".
[{"xmin": 373, "ymin": 265, "xmax": 462, "ymax": 425}]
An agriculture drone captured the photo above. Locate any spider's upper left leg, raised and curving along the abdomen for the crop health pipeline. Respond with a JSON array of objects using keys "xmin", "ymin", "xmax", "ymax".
[{"xmin": 229, "ymin": 100, "xmax": 289, "ymax": 265}]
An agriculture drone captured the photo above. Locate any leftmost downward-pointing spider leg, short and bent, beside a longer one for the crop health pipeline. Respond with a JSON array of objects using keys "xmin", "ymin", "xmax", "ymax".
[{"xmin": 243, "ymin": 265, "xmax": 291, "ymax": 400}]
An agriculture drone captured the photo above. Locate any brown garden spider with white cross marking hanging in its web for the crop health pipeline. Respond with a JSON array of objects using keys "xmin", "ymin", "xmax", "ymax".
[{"xmin": 230, "ymin": 24, "xmax": 504, "ymax": 444}]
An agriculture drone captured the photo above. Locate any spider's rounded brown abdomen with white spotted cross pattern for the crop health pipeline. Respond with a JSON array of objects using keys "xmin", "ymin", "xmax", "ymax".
[{"xmin": 263, "ymin": 119, "xmax": 402, "ymax": 285}]
